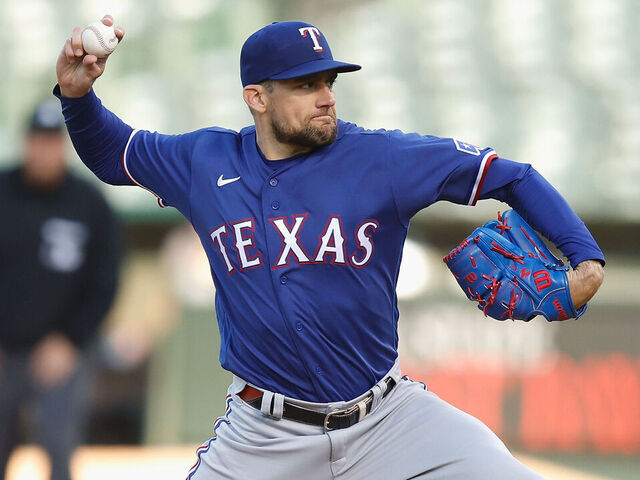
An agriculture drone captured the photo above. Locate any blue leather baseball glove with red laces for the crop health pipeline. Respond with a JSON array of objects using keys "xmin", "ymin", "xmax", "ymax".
[{"xmin": 443, "ymin": 210, "xmax": 587, "ymax": 321}]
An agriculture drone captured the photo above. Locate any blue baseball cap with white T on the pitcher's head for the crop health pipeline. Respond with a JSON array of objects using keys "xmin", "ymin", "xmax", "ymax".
[{"xmin": 240, "ymin": 22, "xmax": 362, "ymax": 87}]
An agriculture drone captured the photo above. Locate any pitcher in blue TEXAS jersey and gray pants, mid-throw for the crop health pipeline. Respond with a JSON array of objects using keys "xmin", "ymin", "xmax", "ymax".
[{"xmin": 54, "ymin": 16, "xmax": 604, "ymax": 480}]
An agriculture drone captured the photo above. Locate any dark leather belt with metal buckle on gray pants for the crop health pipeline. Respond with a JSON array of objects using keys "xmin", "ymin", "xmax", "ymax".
[{"xmin": 238, "ymin": 377, "xmax": 396, "ymax": 430}]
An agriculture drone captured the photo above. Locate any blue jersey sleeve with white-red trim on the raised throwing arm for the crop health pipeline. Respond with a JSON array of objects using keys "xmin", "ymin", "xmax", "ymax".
[{"xmin": 122, "ymin": 130, "xmax": 199, "ymax": 213}]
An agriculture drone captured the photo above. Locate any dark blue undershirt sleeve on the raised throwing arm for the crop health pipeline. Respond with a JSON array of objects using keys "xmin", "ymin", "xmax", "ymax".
[{"xmin": 53, "ymin": 86, "xmax": 133, "ymax": 185}]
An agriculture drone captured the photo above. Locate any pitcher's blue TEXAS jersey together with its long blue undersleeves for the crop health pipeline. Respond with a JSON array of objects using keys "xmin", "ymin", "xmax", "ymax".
[{"xmin": 55, "ymin": 88, "xmax": 602, "ymax": 402}]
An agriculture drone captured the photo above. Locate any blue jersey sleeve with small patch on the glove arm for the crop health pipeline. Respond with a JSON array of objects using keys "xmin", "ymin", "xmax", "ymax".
[{"xmin": 389, "ymin": 131, "xmax": 497, "ymax": 223}]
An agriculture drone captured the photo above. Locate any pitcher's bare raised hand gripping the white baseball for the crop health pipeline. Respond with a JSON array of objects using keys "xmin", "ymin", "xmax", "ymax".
[{"xmin": 56, "ymin": 15, "xmax": 124, "ymax": 97}]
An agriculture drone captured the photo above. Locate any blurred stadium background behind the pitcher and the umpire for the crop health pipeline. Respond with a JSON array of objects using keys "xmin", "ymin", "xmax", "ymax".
[{"xmin": 0, "ymin": 0, "xmax": 640, "ymax": 479}]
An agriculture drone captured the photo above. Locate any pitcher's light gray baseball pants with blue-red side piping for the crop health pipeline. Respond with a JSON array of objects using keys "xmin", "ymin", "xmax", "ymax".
[{"xmin": 187, "ymin": 365, "xmax": 542, "ymax": 480}]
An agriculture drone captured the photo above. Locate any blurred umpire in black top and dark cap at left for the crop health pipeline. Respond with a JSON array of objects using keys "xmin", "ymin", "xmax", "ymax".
[{"xmin": 0, "ymin": 102, "xmax": 120, "ymax": 480}]
